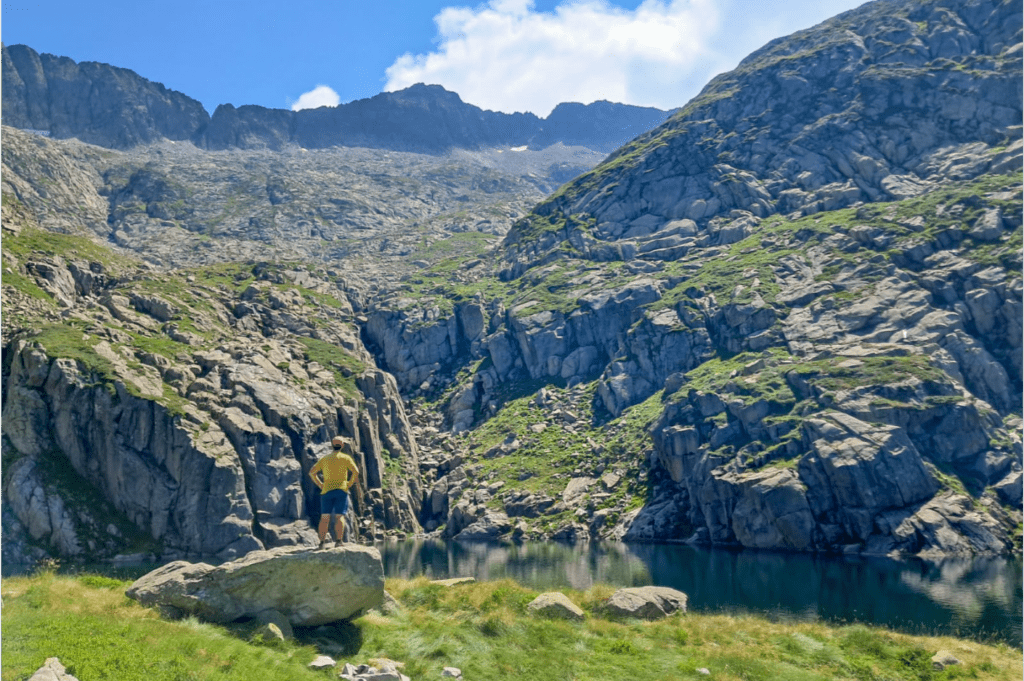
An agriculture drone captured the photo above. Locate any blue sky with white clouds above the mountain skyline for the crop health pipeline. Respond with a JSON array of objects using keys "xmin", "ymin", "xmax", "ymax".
[{"xmin": 0, "ymin": 0, "xmax": 862, "ymax": 116}]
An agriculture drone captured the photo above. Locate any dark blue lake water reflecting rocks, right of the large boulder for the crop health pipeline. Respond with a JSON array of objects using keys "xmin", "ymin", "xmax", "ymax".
[{"xmin": 378, "ymin": 540, "xmax": 1024, "ymax": 646}]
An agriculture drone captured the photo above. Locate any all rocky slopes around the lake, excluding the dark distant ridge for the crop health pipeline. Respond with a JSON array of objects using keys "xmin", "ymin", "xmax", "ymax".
[{"xmin": 3, "ymin": 0, "xmax": 1024, "ymax": 560}]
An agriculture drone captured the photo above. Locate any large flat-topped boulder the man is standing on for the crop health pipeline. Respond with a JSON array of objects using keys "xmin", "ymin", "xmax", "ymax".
[{"xmin": 125, "ymin": 546, "xmax": 384, "ymax": 627}]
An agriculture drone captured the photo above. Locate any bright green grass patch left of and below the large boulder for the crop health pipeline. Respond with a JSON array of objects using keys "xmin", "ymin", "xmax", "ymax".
[{"xmin": 2, "ymin": 572, "xmax": 325, "ymax": 681}]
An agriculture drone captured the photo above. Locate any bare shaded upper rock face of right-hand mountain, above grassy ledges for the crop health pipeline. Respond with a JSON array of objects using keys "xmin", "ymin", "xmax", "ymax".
[{"xmin": 509, "ymin": 0, "xmax": 1022, "ymax": 264}]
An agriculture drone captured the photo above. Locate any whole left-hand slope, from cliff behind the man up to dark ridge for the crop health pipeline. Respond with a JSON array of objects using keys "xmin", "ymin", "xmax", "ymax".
[{"xmin": 2, "ymin": 119, "xmax": 596, "ymax": 562}]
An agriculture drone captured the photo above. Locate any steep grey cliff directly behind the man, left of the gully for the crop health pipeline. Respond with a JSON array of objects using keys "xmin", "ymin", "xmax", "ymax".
[{"xmin": 3, "ymin": 251, "xmax": 422, "ymax": 558}]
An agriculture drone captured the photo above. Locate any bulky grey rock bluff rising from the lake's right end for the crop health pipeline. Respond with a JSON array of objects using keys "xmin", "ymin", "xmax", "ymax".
[{"xmin": 627, "ymin": 349, "xmax": 1020, "ymax": 553}]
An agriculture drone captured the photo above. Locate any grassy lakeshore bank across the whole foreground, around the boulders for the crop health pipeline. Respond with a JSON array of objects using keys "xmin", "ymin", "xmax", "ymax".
[{"xmin": 2, "ymin": 572, "xmax": 1024, "ymax": 681}]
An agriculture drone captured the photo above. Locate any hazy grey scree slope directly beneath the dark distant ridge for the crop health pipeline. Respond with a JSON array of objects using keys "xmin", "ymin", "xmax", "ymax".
[{"xmin": 3, "ymin": 120, "xmax": 601, "ymax": 270}]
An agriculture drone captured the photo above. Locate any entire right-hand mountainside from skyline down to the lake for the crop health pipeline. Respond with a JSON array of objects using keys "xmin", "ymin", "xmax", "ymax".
[{"xmin": 356, "ymin": 2, "xmax": 1024, "ymax": 553}]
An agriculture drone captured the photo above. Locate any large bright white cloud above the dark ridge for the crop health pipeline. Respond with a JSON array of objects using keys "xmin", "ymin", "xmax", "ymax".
[{"xmin": 384, "ymin": 0, "xmax": 722, "ymax": 116}]
